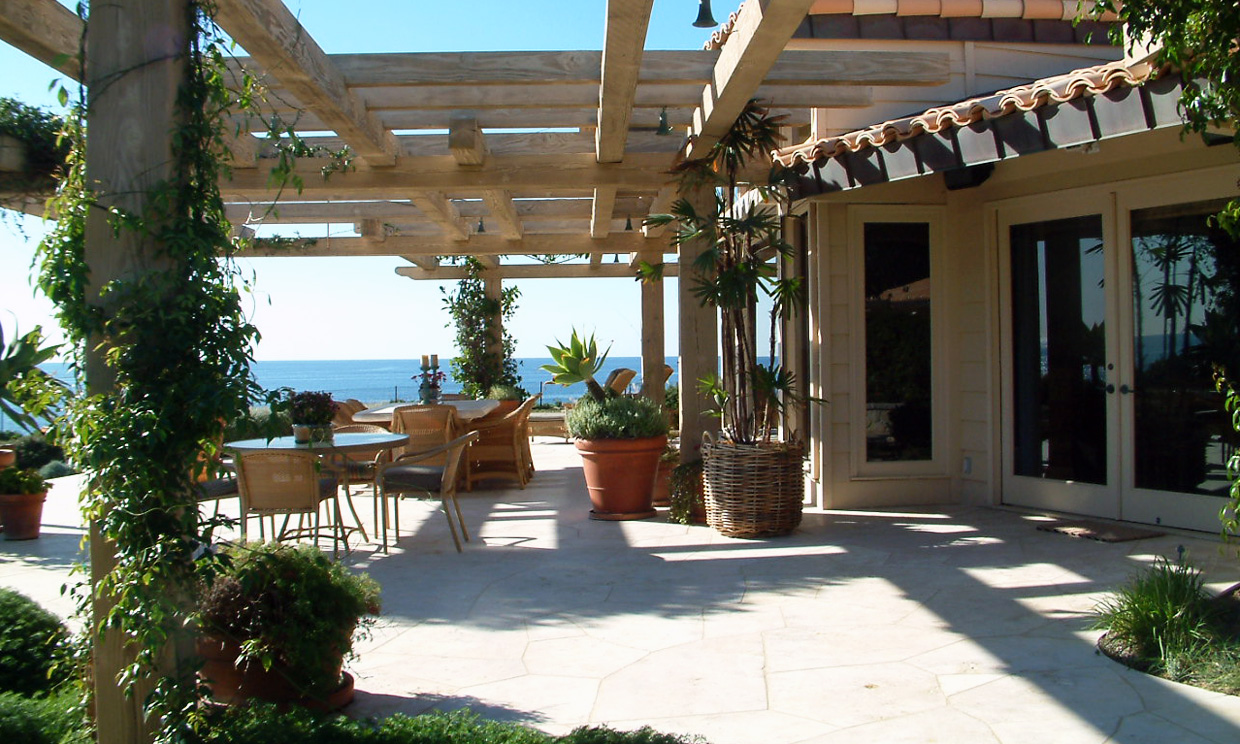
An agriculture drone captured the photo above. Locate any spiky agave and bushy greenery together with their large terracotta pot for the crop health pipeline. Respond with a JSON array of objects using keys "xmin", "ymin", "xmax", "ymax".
[{"xmin": 543, "ymin": 330, "xmax": 667, "ymax": 521}]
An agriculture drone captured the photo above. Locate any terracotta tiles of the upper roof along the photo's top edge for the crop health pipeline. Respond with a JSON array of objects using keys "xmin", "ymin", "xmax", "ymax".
[{"xmin": 704, "ymin": 0, "xmax": 1116, "ymax": 50}]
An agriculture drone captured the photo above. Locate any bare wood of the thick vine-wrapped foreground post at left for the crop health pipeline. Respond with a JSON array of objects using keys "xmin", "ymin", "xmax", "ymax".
[{"xmin": 86, "ymin": 0, "xmax": 190, "ymax": 744}]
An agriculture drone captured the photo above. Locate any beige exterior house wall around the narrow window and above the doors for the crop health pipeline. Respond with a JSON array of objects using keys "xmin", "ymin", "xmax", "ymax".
[{"xmin": 806, "ymin": 129, "xmax": 1240, "ymax": 508}]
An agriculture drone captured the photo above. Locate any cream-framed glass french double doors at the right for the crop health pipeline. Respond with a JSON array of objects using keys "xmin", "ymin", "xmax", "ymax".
[{"xmin": 997, "ymin": 174, "xmax": 1240, "ymax": 531}]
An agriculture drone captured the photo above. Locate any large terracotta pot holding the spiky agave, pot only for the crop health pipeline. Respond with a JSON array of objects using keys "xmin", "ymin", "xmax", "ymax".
[{"xmin": 577, "ymin": 435, "xmax": 667, "ymax": 521}]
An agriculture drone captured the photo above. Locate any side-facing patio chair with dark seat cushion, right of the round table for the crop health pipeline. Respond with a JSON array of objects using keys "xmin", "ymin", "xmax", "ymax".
[{"xmin": 374, "ymin": 432, "xmax": 477, "ymax": 553}]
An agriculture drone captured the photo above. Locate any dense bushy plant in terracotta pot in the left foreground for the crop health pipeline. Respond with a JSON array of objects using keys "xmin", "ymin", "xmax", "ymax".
[{"xmin": 190, "ymin": 543, "xmax": 379, "ymax": 709}]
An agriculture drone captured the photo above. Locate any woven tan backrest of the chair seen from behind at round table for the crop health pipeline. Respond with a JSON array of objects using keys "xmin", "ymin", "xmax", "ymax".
[{"xmin": 237, "ymin": 450, "xmax": 322, "ymax": 515}]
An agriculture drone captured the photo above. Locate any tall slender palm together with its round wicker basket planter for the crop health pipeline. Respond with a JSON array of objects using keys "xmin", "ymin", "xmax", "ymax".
[{"xmin": 646, "ymin": 100, "xmax": 805, "ymax": 537}]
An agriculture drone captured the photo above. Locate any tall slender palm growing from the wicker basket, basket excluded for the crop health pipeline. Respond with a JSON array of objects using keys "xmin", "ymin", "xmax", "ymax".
[{"xmin": 646, "ymin": 100, "xmax": 805, "ymax": 444}]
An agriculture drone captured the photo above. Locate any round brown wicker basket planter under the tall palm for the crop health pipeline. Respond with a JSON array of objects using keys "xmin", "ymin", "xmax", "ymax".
[{"xmin": 702, "ymin": 440, "xmax": 805, "ymax": 537}]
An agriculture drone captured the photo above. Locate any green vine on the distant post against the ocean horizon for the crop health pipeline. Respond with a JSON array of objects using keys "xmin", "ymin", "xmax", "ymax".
[{"xmin": 440, "ymin": 257, "xmax": 521, "ymax": 398}]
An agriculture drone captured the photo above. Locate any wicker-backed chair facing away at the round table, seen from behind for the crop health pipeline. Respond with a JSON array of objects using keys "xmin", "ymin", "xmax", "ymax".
[{"xmin": 236, "ymin": 450, "xmax": 348, "ymax": 554}]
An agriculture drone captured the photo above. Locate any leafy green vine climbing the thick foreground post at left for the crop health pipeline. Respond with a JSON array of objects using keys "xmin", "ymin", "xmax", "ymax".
[{"xmin": 38, "ymin": 0, "xmax": 340, "ymax": 742}]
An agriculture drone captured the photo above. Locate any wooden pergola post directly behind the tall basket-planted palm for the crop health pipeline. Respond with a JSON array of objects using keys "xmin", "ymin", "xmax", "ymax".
[{"xmin": 678, "ymin": 188, "xmax": 719, "ymax": 463}]
